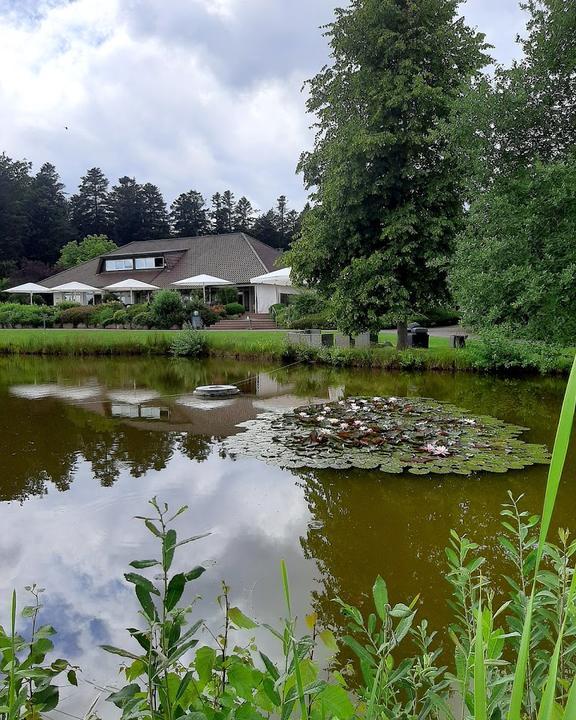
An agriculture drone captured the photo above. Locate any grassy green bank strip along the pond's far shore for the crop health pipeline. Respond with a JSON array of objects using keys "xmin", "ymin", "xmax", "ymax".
[{"xmin": 0, "ymin": 328, "xmax": 575, "ymax": 375}]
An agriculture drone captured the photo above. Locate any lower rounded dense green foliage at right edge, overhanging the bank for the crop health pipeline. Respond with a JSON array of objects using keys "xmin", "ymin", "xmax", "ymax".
[{"xmin": 452, "ymin": 156, "xmax": 576, "ymax": 344}]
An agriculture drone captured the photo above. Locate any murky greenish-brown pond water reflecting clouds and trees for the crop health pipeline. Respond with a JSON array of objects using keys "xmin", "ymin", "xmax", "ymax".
[{"xmin": 0, "ymin": 358, "xmax": 576, "ymax": 714}]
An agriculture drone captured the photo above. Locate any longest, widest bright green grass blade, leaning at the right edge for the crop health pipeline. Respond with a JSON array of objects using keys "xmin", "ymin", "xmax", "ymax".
[{"xmin": 507, "ymin": 360, "xmax": 576, "ymax": 720}]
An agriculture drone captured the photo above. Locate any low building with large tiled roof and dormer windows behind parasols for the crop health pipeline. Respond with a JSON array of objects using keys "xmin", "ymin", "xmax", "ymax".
[{"xmin": 42, "ymin": 233, "xmax": 297, "ymax": 313}]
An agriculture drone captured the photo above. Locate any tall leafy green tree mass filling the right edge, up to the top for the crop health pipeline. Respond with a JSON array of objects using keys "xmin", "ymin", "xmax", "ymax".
[{"xmin": 451, "ymin": 0, "xmax": 576, "ymax": 344}]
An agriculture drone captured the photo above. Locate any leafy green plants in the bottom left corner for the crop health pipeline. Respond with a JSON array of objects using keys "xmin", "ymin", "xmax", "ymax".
[{"xmin": 0, "ymin": 585, "xmax": 78, "ymax": 720}]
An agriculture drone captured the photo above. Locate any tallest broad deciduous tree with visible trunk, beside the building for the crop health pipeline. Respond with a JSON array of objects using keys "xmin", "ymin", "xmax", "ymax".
[{"xmin": 289, "ymin": 0, "xmax": 486, "ymax": 346}]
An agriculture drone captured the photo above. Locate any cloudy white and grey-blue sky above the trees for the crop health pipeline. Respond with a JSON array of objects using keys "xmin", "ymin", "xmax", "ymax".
[{"xmin": 0, "ymin": 0, "xmax": 524, "ymax": 209}]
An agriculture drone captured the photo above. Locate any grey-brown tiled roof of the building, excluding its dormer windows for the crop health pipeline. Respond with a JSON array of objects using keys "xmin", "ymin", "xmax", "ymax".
[{"xmin": 42, "ymin": 233, "xmax": 280, "ymax": 288}]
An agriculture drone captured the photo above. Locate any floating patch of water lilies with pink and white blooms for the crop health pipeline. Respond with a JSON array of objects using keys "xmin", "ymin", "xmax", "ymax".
[{"xmin": 225, "ymin": 396, "xmax": 548, "ymax": 475}]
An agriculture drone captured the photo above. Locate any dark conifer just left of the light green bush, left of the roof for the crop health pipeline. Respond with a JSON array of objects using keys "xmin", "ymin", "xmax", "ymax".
[{"xmin": 23, "ymin": 163, "xmax": 71, "ymax": 264}]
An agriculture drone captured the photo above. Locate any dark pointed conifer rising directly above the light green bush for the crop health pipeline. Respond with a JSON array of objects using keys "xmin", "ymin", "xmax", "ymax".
[{"xmin": 70, "ymin": 168, "xmax": 110, "ymax": 237}]
